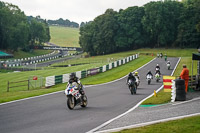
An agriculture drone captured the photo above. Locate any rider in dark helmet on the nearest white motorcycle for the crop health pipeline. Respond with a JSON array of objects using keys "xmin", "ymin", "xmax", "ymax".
[{"xmin": 69, "ymin": 73, "xmax": 85, "ymax": 95}]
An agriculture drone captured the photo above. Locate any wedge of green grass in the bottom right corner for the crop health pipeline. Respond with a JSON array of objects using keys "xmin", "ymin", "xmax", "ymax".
[{"xmin": 116, "ymin": 116, "xmax": 200, "ymax": 133}]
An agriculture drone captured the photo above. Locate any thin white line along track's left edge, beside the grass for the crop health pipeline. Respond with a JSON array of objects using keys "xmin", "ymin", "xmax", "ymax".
[{"xmin": 0, "ymin": 58, "xmax": 156, "ymax": 106}]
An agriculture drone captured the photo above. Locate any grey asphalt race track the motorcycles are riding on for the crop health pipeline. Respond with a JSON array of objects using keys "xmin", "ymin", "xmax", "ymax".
[{"xmin": 0, "ymin": 58, "xmax": 178, "ymax": 133}]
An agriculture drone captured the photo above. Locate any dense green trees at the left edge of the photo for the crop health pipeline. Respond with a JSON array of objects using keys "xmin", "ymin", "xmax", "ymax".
[{"xmin": 0, "ymin": 1, "xmax": 50, "ymax": 51}]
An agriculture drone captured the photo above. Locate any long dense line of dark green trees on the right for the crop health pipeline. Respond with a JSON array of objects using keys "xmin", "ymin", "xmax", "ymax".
[{"xmin": 79, "ymin": 0, "xmax": 200, "ymax": 55}]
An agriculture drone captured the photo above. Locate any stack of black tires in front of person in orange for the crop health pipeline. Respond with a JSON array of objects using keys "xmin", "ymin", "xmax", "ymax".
[{"xmin": 175, "ymin": 79, "xmax": 186, "ymax": 101}]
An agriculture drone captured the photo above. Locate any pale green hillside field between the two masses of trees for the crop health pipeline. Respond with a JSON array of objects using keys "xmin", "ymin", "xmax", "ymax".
[{"xmin": 50, "ymin": 26, "xmax": 80, "ymax": 47}]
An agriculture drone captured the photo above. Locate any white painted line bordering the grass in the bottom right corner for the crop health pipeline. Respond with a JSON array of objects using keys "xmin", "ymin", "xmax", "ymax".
[{"xmin": 95, "ymin": 113, "xmax": 200, "ymax": 133}]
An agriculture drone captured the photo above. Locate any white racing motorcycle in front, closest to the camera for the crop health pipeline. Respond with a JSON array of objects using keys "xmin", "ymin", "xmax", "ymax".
[{"xmin": 65, "ymin": 82, "xmax": 88, "ymax": 110}]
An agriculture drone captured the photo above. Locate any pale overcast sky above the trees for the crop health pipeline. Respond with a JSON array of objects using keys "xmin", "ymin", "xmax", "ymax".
[{"xmin": 0, "ymin": 0, "xmax": 158, "ymax": 24}]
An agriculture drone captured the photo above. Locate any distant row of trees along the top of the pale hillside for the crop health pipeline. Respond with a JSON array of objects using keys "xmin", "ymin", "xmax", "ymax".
[{"xmin": 47, "ymin": 18, "xmax": 79, "ymax": 28}]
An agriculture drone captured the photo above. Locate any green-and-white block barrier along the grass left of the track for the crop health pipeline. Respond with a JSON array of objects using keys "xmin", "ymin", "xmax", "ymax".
[{"xmin": 45, "ymin": 54, "xmax": 138, "ymax": 87}]
